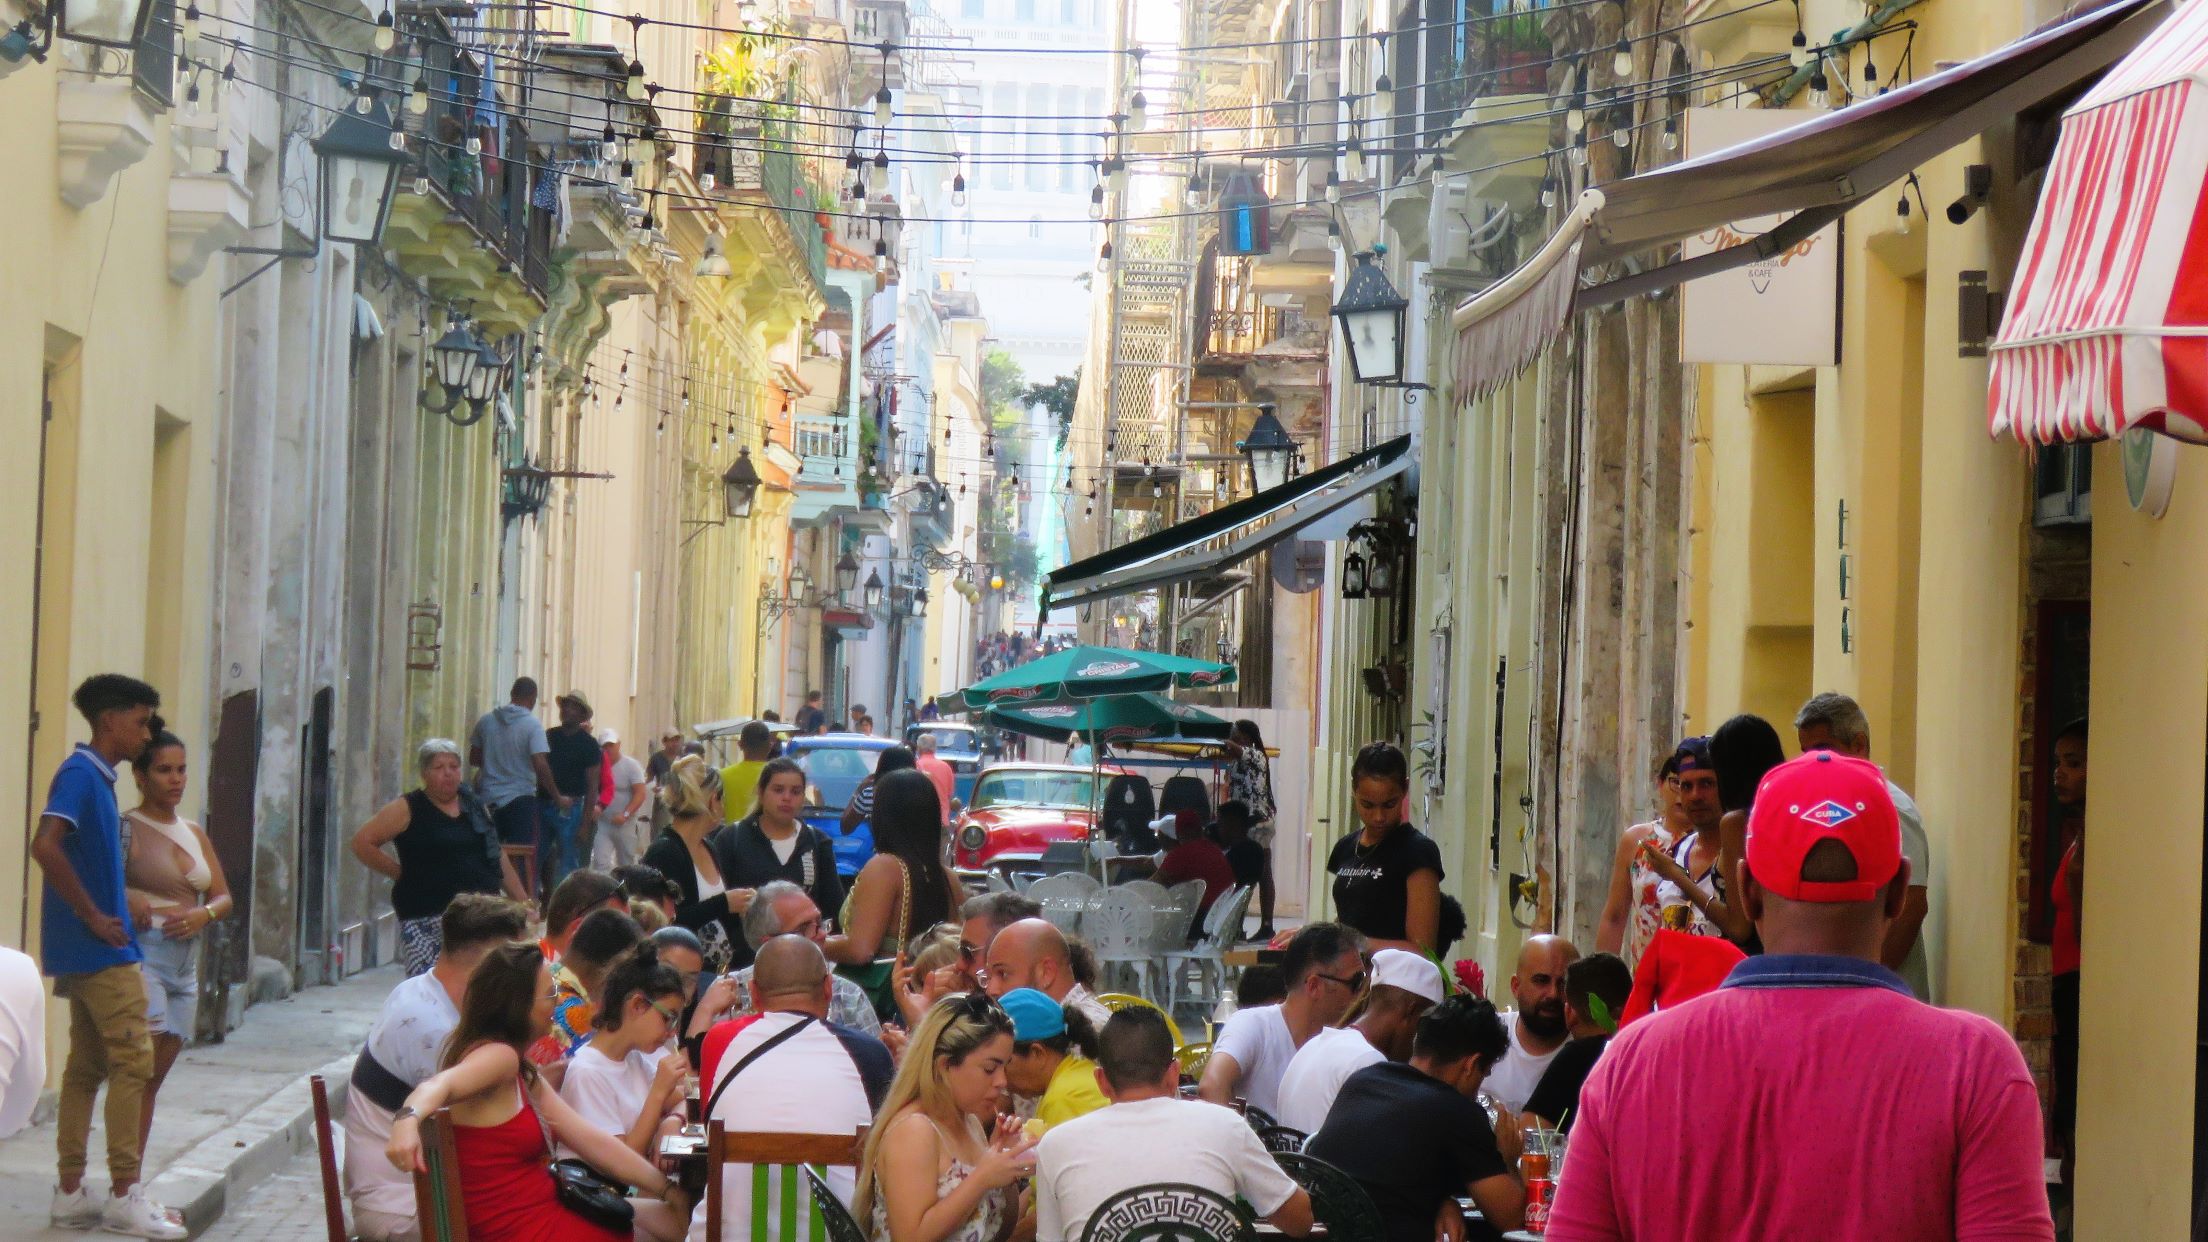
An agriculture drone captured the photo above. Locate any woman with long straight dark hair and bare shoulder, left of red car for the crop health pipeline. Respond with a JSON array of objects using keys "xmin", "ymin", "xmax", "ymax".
[{"xmin": 824, "ymin": 767, "xmax": 963, "ymax": 966}]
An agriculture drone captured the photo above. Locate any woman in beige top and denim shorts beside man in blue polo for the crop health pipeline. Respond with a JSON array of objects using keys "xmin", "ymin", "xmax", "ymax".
[{"xmin": 124, "ymin": 729, "xmax": 230, "ymax": 1147}]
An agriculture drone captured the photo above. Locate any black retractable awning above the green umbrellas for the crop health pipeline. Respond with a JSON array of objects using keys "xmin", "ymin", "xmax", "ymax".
[{"xmin": 1042, "ymin": 435, "xmax": 1411, "ymax": 612}]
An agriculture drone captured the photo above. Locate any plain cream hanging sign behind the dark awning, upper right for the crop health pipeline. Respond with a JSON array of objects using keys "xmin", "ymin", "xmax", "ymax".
[{"xmin": 1678, "ymin": 108, "xmax": 1839, "ymax": 367}]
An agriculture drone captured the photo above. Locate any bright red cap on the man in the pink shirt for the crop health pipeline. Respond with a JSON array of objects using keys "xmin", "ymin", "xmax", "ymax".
[{"xmin": 1747, "ymin": 751, "xmax": 1901, "ymax": 902}]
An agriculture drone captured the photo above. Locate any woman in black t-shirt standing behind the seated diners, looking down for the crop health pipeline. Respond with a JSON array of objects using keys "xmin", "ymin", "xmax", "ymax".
[{"xmin": 1327, "ymin": 743, "xmax": 1442, "ymax": 955}]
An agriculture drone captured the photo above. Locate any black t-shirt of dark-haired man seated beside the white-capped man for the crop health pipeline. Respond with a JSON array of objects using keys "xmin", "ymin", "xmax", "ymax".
[{"xmin": 1303, "ymin": 1061, "xmax": 1510, "ymax": 1242}]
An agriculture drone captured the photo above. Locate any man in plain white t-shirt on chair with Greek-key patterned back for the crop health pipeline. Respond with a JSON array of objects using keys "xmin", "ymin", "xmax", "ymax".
[{"xmin": 1036, "ymin": 1008, "xmax": 1312, "ymax": 1242}]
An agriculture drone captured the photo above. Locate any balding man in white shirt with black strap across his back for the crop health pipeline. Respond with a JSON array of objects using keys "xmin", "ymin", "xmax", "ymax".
[{"xmin": 696, "ymin": 935, "xmax": 896, "ymax": 1242}]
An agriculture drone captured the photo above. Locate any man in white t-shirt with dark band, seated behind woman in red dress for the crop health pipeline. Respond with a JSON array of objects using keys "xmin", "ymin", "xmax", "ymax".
[{"xmin": 344, "ymin": 893, "xmax": 528, "ymax": 1242}]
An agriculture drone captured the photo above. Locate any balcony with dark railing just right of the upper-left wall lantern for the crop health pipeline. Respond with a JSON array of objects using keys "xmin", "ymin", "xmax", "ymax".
[{"xmin": 386, "ymin": 9, "xmax": 552, "ymax": 331}]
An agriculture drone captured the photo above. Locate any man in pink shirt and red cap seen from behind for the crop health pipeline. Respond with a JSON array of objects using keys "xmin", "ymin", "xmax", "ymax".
[{"xmin": 1548, "ymin": 751, "xmax": 2053, "ymax": 1242}]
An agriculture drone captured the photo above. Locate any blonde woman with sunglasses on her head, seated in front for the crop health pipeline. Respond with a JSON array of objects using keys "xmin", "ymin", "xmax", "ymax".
[{"xmin": 852, "ymin": 992, "xmax": 1036, "ymax": 1242}]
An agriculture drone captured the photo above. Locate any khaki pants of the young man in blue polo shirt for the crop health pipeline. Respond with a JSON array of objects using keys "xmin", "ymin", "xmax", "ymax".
[{"xmin": 53, "ymin": 961, "xmax": 152, "ymax": 1185}]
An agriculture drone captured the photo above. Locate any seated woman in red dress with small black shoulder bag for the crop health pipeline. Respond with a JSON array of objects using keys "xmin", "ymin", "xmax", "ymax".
[{"xmin": 384, "ymin": 944, "xmax": 689, "ymax": 1242}]
